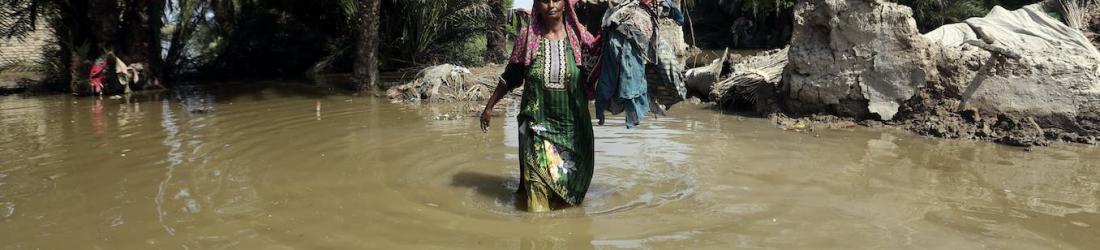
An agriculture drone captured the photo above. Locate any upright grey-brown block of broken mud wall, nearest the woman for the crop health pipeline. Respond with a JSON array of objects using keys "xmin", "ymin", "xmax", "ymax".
[{"xmin": 782, "ymin": 0, "xmax": 936, "ymax": 120}]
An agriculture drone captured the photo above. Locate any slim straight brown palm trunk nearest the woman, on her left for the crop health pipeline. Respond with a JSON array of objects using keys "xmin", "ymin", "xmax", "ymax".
[{"xmin": 354, "ymin": 0, "xmax": 382, "ymax": 91}]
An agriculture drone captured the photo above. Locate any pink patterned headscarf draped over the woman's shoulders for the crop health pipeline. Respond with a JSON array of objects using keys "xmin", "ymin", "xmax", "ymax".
[{"xmin": 508, "ymin": 0, "xmax": 596, "ymax": 66}]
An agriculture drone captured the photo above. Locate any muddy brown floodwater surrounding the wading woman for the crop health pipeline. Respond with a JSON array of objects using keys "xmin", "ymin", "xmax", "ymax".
[{"xmin": 0, "ymin": 84, "xmax": 1100, "ymax": 249}]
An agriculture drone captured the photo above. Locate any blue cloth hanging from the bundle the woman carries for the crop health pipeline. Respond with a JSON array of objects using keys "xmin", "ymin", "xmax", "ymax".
[{"xmin": 596, "ymin": 31, "xmax": 649, "ymax": 128}]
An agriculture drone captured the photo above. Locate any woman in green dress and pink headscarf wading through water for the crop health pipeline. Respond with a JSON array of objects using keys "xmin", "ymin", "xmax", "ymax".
[{"xmin": 481, "ymin": 0, "xmax": 595, "ymax": 211}]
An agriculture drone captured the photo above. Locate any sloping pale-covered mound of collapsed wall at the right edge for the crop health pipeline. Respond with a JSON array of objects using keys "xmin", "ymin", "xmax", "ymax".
[{"xmin": 925, "ymin": 4, "xmax": 1100, "ymax": 144}]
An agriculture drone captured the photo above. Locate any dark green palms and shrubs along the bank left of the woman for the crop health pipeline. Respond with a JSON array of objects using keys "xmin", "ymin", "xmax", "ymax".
[{"xmin": 0, "ymin": 0, "xmax": 499, "ymax": 90}]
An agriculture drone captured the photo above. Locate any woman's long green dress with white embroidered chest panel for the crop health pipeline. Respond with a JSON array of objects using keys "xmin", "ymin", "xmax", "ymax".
[{"xmin": 516, "ymin": 40, "xmax": 594, "ymax": 211}]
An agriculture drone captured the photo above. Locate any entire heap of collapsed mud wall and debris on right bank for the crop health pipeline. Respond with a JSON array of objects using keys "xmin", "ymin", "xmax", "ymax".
[{"xmin": 688, "ymin": 0, "xmax": 1100, "ymax": 146}]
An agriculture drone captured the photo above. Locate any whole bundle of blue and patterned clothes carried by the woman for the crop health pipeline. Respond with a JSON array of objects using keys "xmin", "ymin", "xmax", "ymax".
[{"xmin": 592, "ymin": 0, "xmax": 686, "ymax": 128}]
